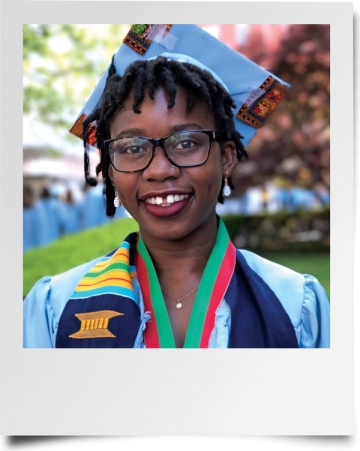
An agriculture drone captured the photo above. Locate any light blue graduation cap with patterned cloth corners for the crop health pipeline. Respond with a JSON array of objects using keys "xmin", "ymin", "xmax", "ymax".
[{"xmin": 70, "ymin": 24, "xmax": 289, "ymax": 146}]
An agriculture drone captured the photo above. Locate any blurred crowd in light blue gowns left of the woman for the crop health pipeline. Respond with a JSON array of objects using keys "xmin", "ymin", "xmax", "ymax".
[{"xmin": 23, "ymin": 184, "xmax": 128, "ymax": 252}]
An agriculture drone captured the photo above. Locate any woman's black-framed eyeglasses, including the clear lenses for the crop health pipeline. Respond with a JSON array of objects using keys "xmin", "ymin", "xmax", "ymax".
[{"xmin": 104, "ymin": 130, "xmax": 225, "ymax": 172}]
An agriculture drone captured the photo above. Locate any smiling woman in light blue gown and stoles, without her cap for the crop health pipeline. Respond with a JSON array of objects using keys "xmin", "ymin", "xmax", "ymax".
[{"xmin": 24, "ymin": 23, "xmax": 329, "ymax": 348}]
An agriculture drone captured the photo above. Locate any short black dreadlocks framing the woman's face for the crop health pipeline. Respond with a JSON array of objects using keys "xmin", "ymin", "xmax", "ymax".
[{"xmin": 83, "ymin": 56, "xmax": 247, "ymax": 216}]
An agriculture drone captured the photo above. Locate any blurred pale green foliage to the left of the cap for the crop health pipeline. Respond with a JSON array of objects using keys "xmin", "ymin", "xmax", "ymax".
[{"xmin": 23, "ymin": 24, "xmax": 129, "ymax": 132}]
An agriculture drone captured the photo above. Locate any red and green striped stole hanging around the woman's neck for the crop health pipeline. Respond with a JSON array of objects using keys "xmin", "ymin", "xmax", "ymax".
[{"xmin": 136, "ymin": 220, "xmax": 236, "ymax": 348}]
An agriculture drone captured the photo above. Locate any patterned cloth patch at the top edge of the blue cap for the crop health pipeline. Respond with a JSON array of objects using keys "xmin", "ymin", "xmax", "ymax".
[{"xmin": 124, "ymin": 24, "xmax": 171, "ymax": 56}]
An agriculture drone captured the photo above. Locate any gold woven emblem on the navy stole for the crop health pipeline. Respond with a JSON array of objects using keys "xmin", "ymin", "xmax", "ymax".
[{"xmin": 69, "ymin": 310, "xmax": 124, "ymax": 339}]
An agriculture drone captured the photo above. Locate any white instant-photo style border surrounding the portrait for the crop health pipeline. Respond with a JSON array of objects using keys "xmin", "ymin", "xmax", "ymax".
[{"xmin": 0, "ymin": 1, "xmax": 354, "ymax": 436}]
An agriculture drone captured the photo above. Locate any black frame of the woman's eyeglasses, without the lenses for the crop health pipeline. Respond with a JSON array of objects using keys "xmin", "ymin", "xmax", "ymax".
[{"xmin": 103, "ymin": 129, "xmax": 227, "ymax": 173}]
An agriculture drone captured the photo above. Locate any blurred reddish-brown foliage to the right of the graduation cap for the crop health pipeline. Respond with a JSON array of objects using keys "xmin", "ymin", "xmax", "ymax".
[{"xmin": 233, "ymin": 25, "xmax": 330, "ymax": 198}]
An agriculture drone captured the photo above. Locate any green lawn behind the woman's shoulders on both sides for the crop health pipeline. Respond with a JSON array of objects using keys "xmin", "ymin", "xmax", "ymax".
[{"xmin": 23, "ymin": 218, "xmax": 330, "ymax": 302}]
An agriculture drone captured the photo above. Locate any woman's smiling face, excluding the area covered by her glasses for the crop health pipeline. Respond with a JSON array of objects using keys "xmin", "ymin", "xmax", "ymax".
[{"xmin": 109, "ymin": 89, "xmax": 236, "ymax": 245}]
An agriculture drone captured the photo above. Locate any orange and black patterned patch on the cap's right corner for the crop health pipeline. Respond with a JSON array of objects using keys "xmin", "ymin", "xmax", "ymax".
[{"xmin": 236, "ymin": 75, "xmax": 288, "ymax": 128}]
